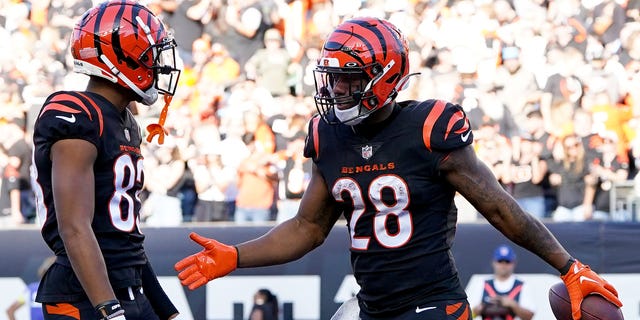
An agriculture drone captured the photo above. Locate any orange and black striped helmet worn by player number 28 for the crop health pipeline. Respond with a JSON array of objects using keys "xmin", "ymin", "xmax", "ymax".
[{"xmin": 314, "ymin": 17, "xmax": 409, "ymax": 124}]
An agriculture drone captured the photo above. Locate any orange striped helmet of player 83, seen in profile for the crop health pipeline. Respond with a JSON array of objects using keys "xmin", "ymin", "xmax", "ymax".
[{"xmin": 70, "ymin": 0, "xmax": 180, "ymax": 105}]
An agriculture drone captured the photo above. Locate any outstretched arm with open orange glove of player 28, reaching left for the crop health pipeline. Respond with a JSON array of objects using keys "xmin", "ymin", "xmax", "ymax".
[{"xmin": 175, "ymin": 165, "xmax": 340, "ymax": 290}]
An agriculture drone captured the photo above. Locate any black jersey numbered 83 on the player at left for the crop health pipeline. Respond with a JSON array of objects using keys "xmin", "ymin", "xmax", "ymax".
[{"xmin": 32, "ymin": 91, "xmax": 146, "ymax": 297}]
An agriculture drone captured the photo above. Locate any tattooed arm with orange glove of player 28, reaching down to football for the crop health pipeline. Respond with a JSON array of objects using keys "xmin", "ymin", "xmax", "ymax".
[{"xmin": 440, "ymin": 146, "xmax": 622, "ymax": 319}]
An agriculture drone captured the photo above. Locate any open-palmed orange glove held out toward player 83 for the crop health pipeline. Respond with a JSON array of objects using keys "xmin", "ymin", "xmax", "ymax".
[{"xmin": 174, "ymin": 232, "xmax": 238, "ymax": 290}]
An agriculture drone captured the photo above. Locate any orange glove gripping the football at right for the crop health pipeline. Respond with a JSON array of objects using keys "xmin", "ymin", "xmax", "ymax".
[{"xmin": 560, "ymin": 260, "xmax": 622, "ymax": 320}]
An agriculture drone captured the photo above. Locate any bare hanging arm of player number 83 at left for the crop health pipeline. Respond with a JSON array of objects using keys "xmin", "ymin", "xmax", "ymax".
[{"xmin": 50, "ymin": 139, "xmax": 117, "ymax": 306}]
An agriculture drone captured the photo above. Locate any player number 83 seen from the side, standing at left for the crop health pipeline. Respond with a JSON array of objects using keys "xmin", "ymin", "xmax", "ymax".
[{"xmin": 32, "ymin": 0, "xmax": 180, "ymax": 320}]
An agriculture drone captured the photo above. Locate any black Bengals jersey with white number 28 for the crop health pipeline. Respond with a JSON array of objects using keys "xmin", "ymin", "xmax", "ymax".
[{"xmin": 305, "ymin": 100, "xmax": 473, "ymax": 315}]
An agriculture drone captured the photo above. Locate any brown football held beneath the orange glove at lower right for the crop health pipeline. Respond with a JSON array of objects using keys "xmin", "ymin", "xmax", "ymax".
[{"xmin": 549, "ymin": 282, "xmax": 624, "ymax": 320}]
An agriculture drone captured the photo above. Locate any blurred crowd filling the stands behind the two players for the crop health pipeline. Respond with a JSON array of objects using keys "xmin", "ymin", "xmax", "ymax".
[{"xmin": 0, "ymin": 0, "xmax": 640, "ymax": 226}]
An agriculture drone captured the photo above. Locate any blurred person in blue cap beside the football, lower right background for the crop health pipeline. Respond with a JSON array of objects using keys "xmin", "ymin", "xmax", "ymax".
[{"xmin": 469, "ymin": 245, "xmax": 536, "ymax": 320}]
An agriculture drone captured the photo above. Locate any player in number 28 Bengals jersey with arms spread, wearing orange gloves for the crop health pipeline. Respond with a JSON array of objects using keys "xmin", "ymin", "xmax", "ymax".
[{"xmin": 175, "ymin": 18, "xmax": 620, "ymax": 320}]
